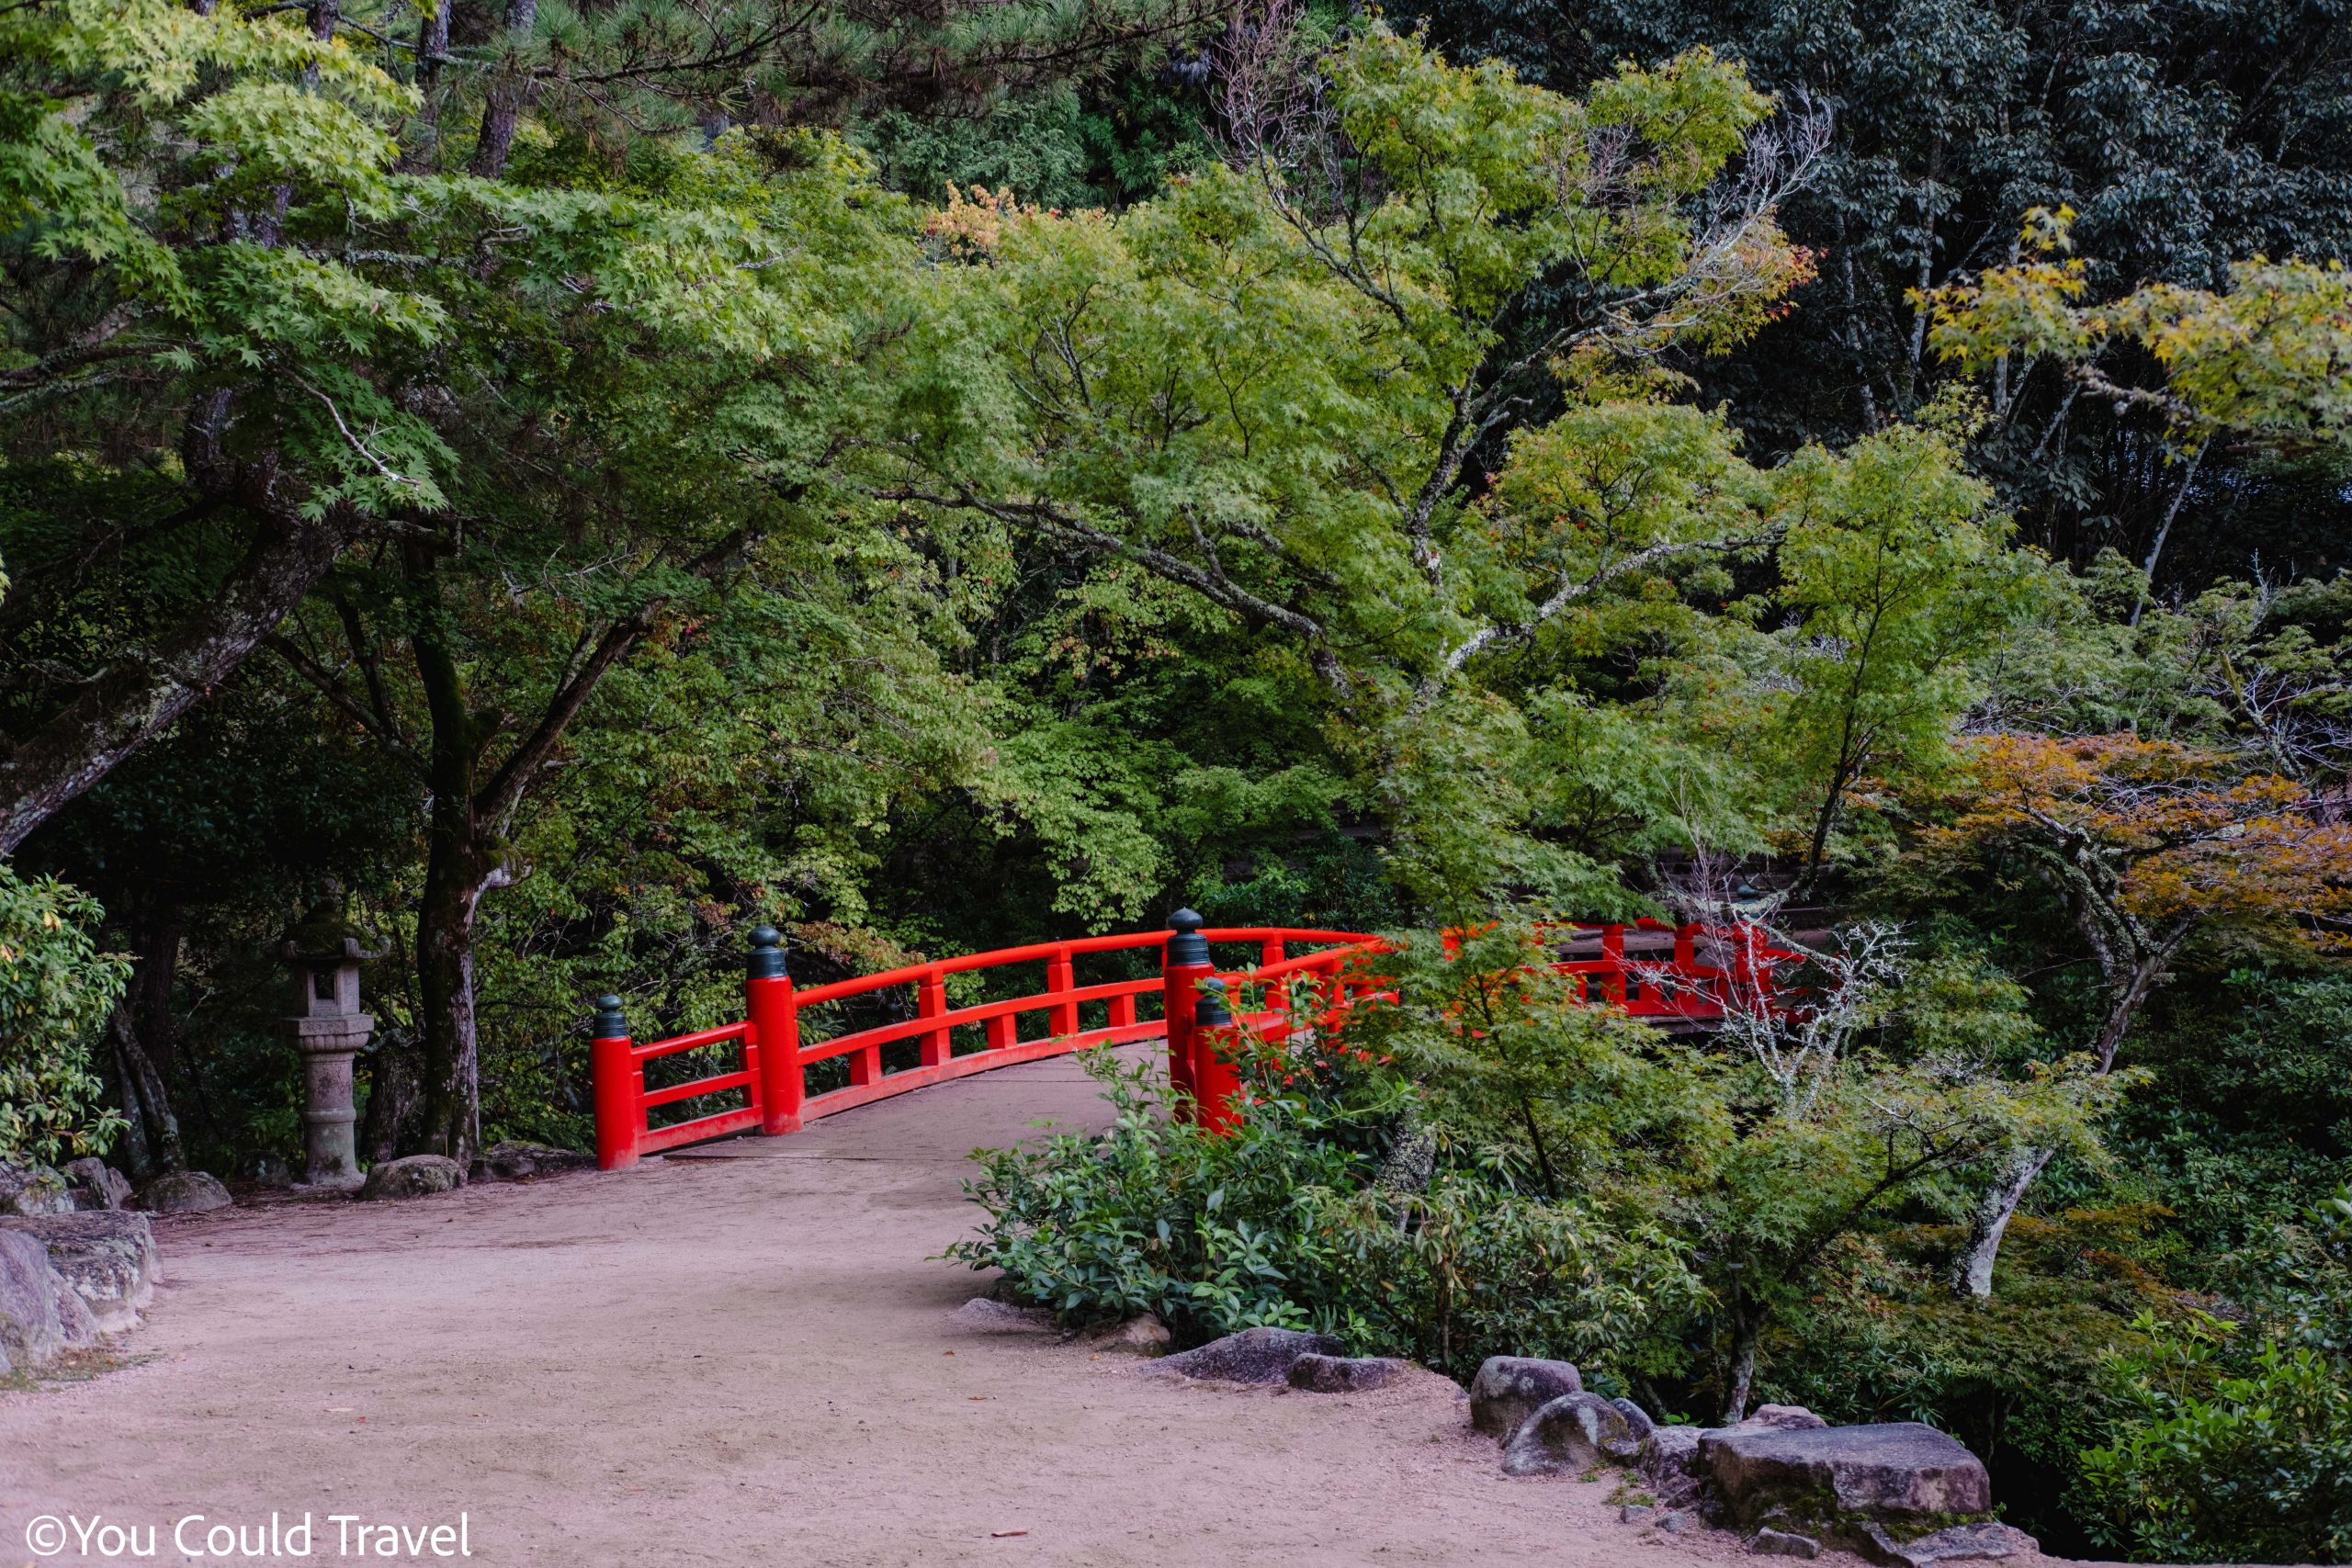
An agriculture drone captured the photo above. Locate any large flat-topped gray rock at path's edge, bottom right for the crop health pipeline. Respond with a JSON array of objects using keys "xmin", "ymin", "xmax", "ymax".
[{"xmin": 1698, "ymin": 1422, "xmax": 1992, "ymax": 1526}]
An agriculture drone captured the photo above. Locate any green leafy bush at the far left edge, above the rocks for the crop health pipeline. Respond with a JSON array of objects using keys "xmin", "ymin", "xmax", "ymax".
[{"xmin": 0, "ymin": 865, "xmax": 130, "ymax": 1164}]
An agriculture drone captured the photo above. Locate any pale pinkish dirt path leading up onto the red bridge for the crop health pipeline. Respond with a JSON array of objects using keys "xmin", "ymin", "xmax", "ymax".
[{"xmin": 0, "ymin": 1060, "xmax": 2051, "ymax": 1568}]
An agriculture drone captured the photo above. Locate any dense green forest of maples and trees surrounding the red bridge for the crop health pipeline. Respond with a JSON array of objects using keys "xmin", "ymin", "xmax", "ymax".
[{"xmin": 0, "ymin": 0, "xmax": 2352, "ymax": 1561}]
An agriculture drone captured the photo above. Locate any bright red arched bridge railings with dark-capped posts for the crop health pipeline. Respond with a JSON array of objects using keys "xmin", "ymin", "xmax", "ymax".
[{"xmin": 591, "ymin": 909, "xmax": 1802, "ymax": 1170}]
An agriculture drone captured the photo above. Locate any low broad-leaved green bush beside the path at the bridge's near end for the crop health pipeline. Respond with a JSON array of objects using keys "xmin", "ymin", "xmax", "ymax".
[{"xmin": 948, "ymin": 1039, "xmax": 1696, "ymax": 1375}]
